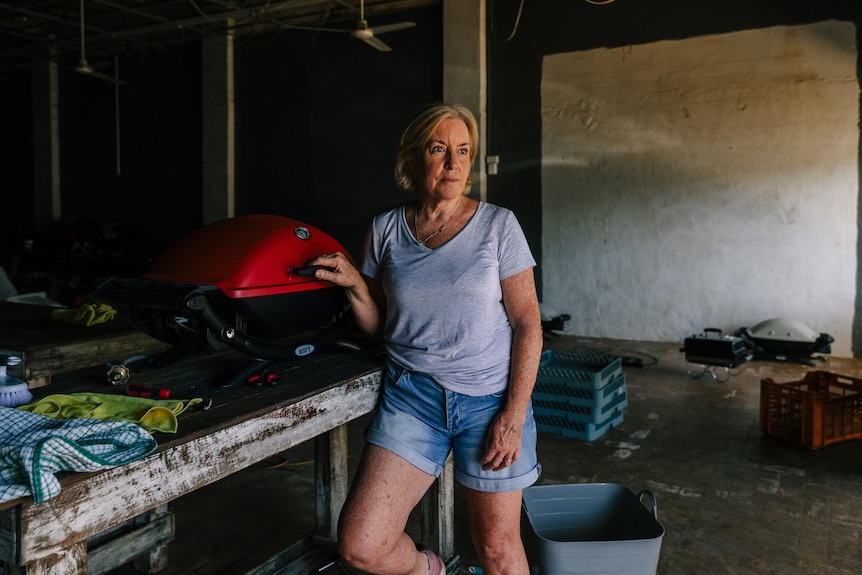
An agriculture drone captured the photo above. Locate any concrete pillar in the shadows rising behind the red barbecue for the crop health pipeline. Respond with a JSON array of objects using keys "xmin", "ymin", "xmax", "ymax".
[{"xmin": 201, "ymin": 28, "xmax": 236, "ymax": 224}]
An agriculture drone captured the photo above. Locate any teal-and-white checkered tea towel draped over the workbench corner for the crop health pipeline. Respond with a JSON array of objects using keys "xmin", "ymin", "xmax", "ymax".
[{"xmin": 0, "ymin": 406, "xmax": 158, "ymax": 503}]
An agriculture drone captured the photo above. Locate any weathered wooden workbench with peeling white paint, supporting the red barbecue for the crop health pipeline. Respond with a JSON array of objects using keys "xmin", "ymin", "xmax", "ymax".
[{"xmin": 0, "ymin": 351, "xmax": 454, "ymax": 575}]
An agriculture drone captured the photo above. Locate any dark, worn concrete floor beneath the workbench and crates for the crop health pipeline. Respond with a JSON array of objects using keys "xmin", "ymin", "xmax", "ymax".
[{"xmin": 113, "ymin": 337, "xmax": 862, "ymax": 575}]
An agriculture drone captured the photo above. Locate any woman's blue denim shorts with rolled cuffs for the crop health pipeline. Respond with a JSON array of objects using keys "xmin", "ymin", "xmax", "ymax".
[{"xmin": 365, "ymin": 360, "xmax": 542, "ymax": 492}]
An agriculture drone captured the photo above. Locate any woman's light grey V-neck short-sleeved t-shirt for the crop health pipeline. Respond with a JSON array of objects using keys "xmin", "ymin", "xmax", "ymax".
[{"xmin": 362, "ymin": 202, "xmax": 536, "ymax": 395}]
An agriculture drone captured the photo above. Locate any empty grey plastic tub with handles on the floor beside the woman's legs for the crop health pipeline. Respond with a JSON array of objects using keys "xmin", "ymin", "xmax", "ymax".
[{"xmin": 523, "ymin": 483, "xmax": 664, "ymax": 575}]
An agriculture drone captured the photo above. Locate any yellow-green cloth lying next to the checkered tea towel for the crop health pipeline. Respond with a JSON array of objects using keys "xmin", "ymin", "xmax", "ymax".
[{"xmin": 18, "ymin": 393, "xmax": 202, "ymax": 433}]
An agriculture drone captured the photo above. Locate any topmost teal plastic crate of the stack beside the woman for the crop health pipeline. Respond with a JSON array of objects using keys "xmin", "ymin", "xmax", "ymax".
[{"xmin": 536, "ymin": 350, "xmax": 623, "ymax": 389}]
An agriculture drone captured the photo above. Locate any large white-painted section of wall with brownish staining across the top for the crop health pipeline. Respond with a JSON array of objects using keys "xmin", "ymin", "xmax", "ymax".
[{"xmin": 542, "ymin": 22, "xmax": 859, "ymax": 356}]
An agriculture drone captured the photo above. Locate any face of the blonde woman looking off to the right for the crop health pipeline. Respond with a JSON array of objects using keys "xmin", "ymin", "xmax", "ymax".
[{"xmin": 413, "ymin": 118, "xmax": 470, "ymax": 199}]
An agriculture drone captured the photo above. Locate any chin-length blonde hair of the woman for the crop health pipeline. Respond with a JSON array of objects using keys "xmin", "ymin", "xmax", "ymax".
[{"xmin": 395, "ymin": 103, "xmax": 479, "ymax": 191}]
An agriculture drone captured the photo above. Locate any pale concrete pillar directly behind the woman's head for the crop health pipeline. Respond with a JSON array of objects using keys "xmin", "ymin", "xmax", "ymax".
[{"xmin": 443, "ymin": 0, "xmax": 489, "ymax": 200}]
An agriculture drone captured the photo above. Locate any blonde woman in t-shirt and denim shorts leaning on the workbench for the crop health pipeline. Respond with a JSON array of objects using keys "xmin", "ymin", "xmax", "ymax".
[{"xmin": 310, "ymin": 104, "xmax": 542, "ymax": 575}]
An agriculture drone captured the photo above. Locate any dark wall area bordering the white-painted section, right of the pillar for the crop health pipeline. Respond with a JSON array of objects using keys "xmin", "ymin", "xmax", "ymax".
[{"xmin": 488, "ymin": 0, "xmax": 862, "ymax": 302}]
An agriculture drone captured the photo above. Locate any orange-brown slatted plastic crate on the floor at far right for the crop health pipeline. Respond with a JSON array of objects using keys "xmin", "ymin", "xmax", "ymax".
[{"xmin": 760, "ymin": 371, "xmax": 862, "ymax": 449}]
